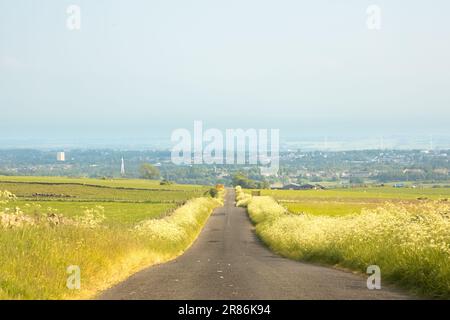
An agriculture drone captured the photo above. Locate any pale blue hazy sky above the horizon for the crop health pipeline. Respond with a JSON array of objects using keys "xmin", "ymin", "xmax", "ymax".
[{"xmin": 0, "ymin": 0, "xmax": 450, "ymax": 142}]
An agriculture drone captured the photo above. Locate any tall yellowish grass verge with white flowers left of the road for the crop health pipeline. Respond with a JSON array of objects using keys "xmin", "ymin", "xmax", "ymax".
[{"xmin": 0, "ymin": 192, "xmax": 221, "ymax": 299}]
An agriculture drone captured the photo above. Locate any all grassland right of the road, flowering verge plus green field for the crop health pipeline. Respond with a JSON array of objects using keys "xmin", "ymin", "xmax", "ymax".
[{"xmin": 241, "ymin": 187, "xmax": 450, "ymax": 299}]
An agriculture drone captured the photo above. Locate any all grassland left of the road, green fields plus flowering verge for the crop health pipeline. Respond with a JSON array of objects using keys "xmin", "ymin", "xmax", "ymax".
[{"xmin": 0, "ymin": 176, "xmax": 220, "ymax": 299}]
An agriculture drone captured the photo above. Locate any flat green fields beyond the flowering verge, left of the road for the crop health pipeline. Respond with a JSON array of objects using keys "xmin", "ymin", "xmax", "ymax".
[{"xmin": 0, "ymin": 176, "xmax": 207, "ymax": 224}]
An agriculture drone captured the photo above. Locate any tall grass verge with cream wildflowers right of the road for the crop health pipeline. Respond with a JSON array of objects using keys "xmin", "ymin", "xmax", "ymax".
[{"xmin": 238, "ymin": 190, "xmax": 450, "ymax": 298}]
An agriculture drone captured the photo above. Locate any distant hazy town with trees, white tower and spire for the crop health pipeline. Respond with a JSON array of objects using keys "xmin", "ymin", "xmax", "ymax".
[{"xmin": 0, "ymin": 149, "xmax": 450, "ymax": 189}]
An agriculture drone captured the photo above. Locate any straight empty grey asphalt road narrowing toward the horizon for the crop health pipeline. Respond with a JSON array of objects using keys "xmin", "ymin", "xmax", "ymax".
[{"xmin": 98, "ymin": 189, "xmax": 408, "ymax": 299}]
